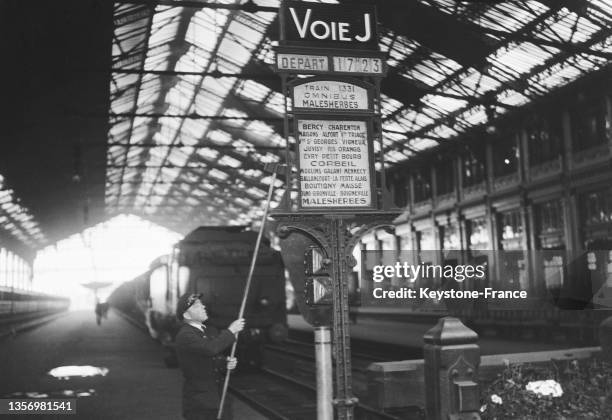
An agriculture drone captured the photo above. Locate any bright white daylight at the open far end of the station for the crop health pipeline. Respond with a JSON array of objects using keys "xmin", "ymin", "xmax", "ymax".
[{"xmin": 33, "ymin": 215, "xmax": 181, "ymax": 310}]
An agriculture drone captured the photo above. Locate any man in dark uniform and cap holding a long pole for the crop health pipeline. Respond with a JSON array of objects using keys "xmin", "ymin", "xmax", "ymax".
[{"xmin": 176, "ymin": 294, "xmax": 244, "ymax": 420}]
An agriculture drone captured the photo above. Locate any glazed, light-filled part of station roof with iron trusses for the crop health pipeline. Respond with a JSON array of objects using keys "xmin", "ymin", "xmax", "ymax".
[{"xmin": 106, "ymin": 0, "xmax": 612, "ymax": 232}]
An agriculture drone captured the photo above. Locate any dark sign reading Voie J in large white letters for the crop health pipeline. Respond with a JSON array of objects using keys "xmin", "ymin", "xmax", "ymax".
[{"xmin": 281, "ymin": 0, "xmax": 378, "ymax": 50}]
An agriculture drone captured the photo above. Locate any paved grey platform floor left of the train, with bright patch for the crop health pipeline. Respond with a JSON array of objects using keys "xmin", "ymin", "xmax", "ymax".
[{"xmin": 0, "ymin": 310, "xmax": 265, "ymax": 420}]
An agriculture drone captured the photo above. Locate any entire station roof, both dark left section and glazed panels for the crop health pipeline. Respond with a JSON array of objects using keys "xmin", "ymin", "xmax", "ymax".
[{"xmin": 0, "ymin": 0, "xmax": 612, "ymax": 253}]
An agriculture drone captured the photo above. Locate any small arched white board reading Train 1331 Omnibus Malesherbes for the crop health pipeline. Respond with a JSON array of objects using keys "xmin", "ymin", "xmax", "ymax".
[{"xmin": 293, "ymin": 80, "xmax": 370, "ymax": 111}]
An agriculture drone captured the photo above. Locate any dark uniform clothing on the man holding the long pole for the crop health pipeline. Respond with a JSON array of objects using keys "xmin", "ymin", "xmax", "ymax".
[{"xmin": 175, "ymin": 323, "xmax": 235, "ymax": 420}]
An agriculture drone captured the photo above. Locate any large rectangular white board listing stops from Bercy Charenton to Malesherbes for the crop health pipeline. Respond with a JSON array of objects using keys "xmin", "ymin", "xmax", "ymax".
[{"xmin": 297, "ymin": 119, "xmax": 372, "ymax": 209}]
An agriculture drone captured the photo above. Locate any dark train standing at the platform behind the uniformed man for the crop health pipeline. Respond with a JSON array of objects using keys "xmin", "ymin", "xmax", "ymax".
[{"xmin": 109, "ymin": 226, "xmax": 287, "ymax": 366}]
